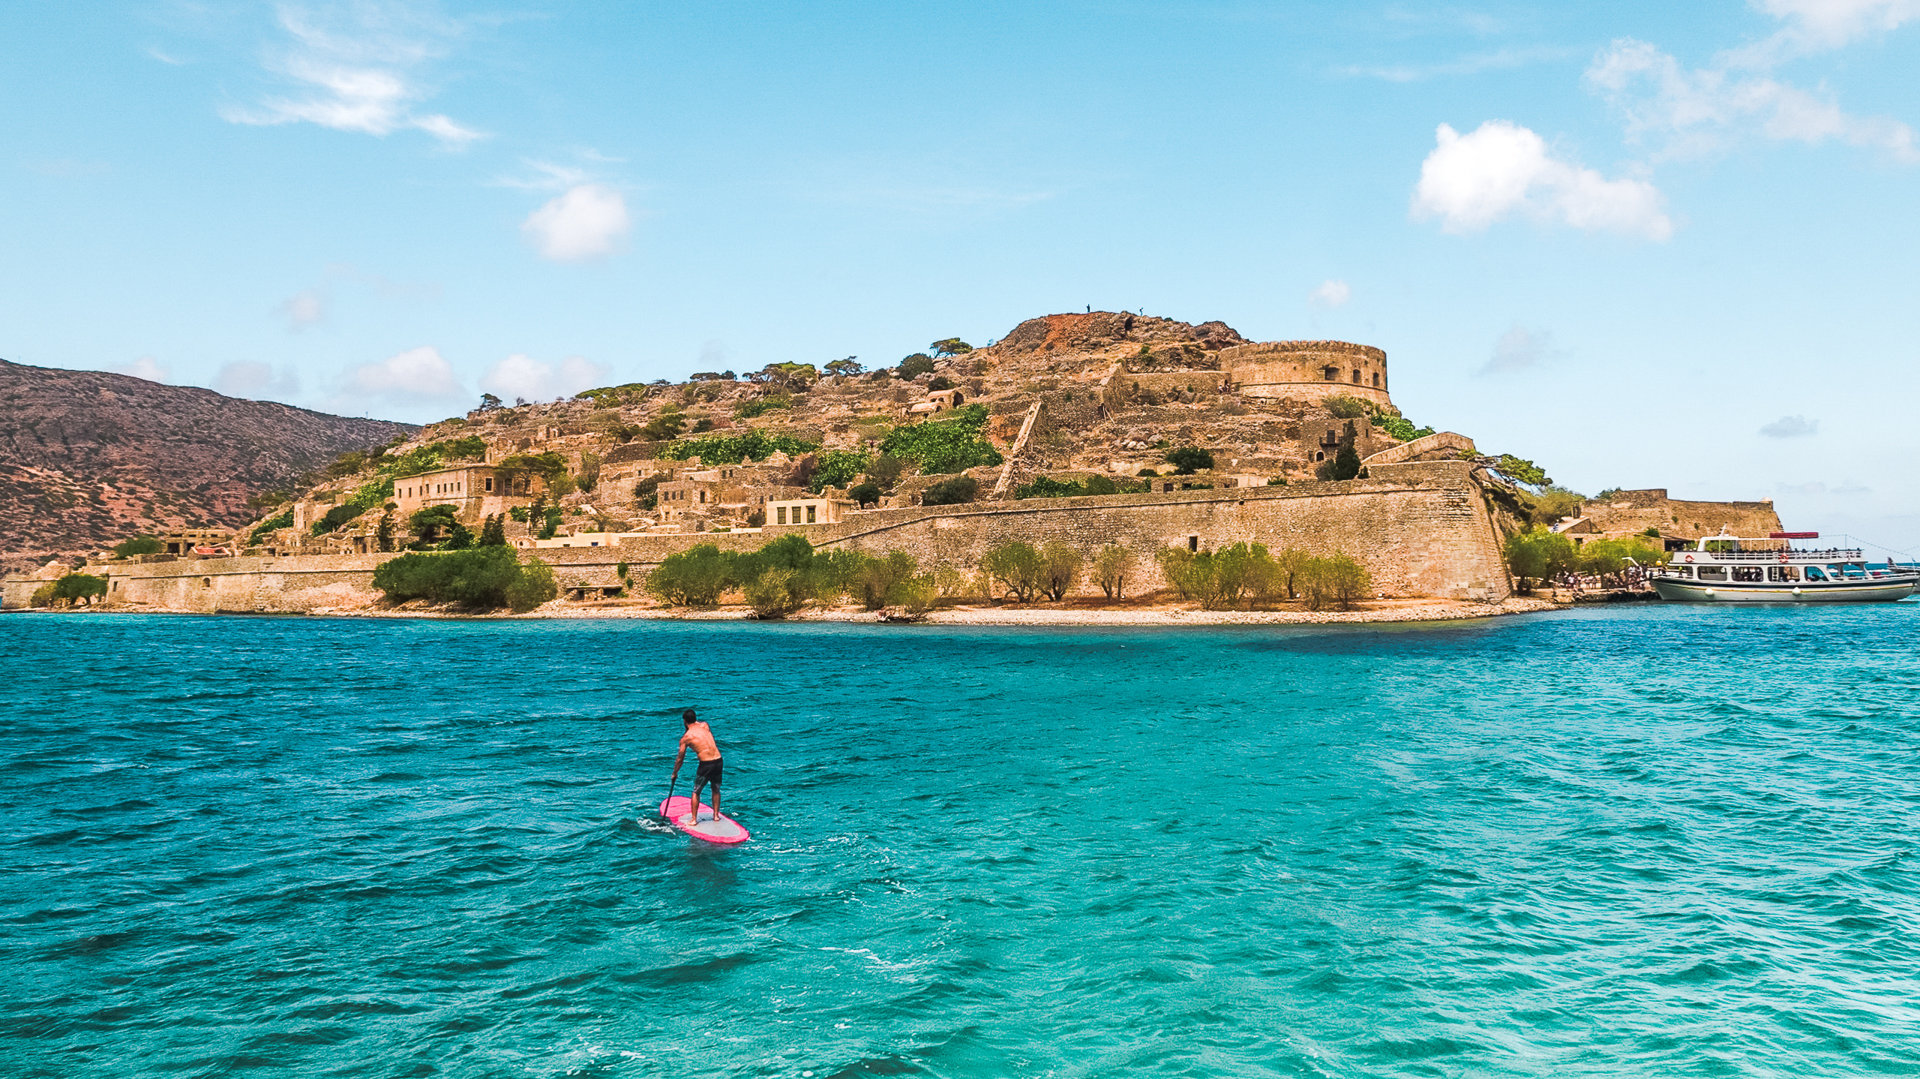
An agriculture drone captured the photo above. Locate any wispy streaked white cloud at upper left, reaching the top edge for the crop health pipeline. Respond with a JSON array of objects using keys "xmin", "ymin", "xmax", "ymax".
[{"xmin": 221, "ymin": 4, "xmax": 482, "ymax": 148}]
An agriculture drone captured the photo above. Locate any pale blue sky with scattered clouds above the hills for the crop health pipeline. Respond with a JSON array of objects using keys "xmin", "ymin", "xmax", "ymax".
[{"xmin": 0, "ymin": 0, "xmax": 1920, "ymax": 551}]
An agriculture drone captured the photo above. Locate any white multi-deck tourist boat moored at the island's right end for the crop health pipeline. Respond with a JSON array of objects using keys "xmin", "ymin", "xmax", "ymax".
[{"xmin": 1649, "ymin": 532, "xmax": 1920, "ymax": 603}]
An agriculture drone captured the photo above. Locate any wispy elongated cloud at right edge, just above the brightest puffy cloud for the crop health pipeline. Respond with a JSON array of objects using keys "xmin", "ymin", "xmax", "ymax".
[{"xmin": 1586, "ymin": 38, "xmax": 1920, "ymax": 163}]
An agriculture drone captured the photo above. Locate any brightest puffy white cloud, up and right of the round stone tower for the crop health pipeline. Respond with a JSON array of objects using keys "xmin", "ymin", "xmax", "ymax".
[{"xmin": 1413, "ymin": 119, "xmax": 1674, "ymax": 240}]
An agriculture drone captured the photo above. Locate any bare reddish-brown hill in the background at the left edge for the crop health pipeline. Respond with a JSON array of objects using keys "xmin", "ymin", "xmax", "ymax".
[{"xmin": 0, "ymin": 361, "xmax": 417, "ymax": 564}]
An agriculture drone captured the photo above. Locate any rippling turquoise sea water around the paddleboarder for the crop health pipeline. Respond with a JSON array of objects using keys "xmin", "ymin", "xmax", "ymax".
[{"xmin": 0, "ymin": 605, "xmax": 1920, "ymax": 1079}]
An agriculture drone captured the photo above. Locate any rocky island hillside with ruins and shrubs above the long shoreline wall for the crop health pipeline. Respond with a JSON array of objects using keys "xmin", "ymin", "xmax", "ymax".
[{"xmin": 250, "ymin": 311, "xmax": 1451, "ymax": 551}]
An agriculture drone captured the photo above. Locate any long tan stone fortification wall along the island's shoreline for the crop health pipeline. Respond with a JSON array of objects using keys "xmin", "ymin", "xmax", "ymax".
[{"xmin": 4, "ymin": 461, "xmax": 1509, "ymax": 612}]
